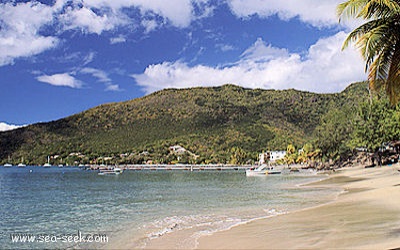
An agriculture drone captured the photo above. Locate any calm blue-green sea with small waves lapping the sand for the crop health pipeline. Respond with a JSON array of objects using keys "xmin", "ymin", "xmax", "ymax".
[{"xmin": 0, "ymin": 166, "xmax": 339, "ymax": 249}]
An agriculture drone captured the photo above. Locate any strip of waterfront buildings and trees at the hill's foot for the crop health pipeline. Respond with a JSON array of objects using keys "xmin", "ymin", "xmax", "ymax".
[{"xmin": 4, "ymin": 141, "xmax": 400, "ymax": 170}]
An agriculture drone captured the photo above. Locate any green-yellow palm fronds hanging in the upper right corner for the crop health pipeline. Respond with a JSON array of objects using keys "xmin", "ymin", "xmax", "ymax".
[{"xmin": 337, "ymin": 0, "xmax": 400, "ymax": 104}]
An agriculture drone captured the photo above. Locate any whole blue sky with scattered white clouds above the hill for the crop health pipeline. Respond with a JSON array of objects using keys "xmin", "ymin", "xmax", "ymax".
[{"xmin": 0, "ymin": 0, "xmax": 366, "ymax": 131}]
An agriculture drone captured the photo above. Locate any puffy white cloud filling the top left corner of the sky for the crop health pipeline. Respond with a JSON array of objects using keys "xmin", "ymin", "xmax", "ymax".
[{"xmin": 0, "ymin": 2, "xmax": 58, "ymax": 66}]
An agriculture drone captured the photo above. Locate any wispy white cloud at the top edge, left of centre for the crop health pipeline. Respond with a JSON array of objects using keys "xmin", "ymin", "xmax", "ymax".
[{"xmin": 63, "ymin": 0, "xmax": 213, "ymax": 34}]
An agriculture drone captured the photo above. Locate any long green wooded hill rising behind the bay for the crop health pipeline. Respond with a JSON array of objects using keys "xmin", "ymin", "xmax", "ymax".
[{"xmin": 0, "ymin": 83, "xmax": 368, "ymax": 164}]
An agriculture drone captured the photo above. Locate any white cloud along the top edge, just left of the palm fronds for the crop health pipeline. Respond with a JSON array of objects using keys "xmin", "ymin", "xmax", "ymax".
[{"xmin": 227, "ymin": 0, "xmax": 343, "ymax": 27}]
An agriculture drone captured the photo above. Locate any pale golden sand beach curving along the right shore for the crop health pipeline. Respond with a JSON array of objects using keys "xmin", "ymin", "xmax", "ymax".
[{"xmin": 198, "ymin": 165, "xmax": 400, "ymax": 249}]
